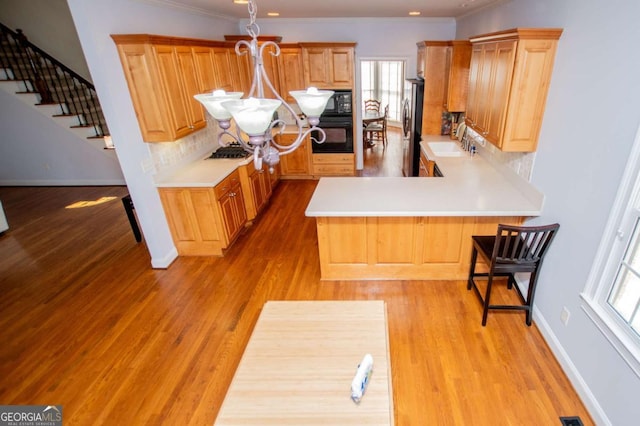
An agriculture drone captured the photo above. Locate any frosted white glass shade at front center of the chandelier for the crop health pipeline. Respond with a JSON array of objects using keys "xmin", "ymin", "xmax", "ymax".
[{"xmin": 222, "ymin": 98, "xmax": 282, "ymax": 135}]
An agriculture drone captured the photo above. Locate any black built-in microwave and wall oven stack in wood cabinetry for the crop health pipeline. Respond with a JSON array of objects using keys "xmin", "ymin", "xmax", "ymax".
[{"xmin": 311, "ymin": 90, "xmax": 353, "ymax": 153}]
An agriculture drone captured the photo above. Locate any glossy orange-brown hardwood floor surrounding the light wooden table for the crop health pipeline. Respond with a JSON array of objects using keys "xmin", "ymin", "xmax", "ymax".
[{"xmin": 0, "ymin": 174, "xmax": 593, "ymax": 425}]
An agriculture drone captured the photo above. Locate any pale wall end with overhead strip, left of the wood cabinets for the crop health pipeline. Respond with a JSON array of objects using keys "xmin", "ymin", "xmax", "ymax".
[{"xmin": 68, "ymin": 0, "xmax": 236, "ymax": 267}]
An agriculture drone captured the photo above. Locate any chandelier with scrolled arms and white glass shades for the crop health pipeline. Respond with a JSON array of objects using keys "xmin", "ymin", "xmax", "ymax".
[{"xmin": 194, "ymin": 0, "xmax": 333, "ymax": 173}]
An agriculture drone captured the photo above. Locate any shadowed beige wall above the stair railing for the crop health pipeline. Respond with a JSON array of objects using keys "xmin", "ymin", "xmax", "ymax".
[{"xmin": 0, "ymin": 0, "xmax": 91, "ymax": 81}]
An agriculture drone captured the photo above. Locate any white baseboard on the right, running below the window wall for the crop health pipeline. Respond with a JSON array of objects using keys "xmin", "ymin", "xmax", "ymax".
[{"xmin": 533, "ymin": 306, "xmax": 613, "ymax": 426}]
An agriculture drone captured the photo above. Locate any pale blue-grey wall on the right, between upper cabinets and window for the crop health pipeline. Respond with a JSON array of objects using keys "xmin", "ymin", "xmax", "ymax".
[{"xmin": 457, "ymin": 0, "xmax": 640, "ymax": 425}]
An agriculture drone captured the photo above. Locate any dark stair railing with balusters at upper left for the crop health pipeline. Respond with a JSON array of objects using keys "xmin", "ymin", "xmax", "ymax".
[{"xmin": 0, "ymin": 23, "xmax": 109, "ymax": 137}]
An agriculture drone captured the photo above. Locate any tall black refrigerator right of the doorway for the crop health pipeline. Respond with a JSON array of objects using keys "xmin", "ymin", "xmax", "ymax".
[{"xmin": 402, "ymin": 78, "xmax": 424, "ymax": 177}]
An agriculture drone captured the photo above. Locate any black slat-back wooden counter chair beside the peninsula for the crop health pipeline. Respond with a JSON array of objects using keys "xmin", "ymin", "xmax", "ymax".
[{"xmin": 467, "ymin": 223, "xmax": 560, "ymax": 326}]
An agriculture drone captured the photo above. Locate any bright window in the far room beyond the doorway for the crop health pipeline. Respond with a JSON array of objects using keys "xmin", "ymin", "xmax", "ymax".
[{"xmin": 360, "ymin": 61, "xmax": 404, "ymax": 122}]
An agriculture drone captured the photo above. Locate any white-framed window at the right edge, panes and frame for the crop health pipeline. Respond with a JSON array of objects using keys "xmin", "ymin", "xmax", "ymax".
[{"xmin": 582, "ymin": 123, "xmax": 640, "ymax": 377}]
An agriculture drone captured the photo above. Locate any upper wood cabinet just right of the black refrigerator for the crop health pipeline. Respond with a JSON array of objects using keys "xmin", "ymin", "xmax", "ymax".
[{"xmin": 444, "ymin": 40, "xmax": 471, "ymax": 112}]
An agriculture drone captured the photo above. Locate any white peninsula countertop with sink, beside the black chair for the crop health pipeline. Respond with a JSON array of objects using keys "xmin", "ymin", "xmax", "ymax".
[{"xmin": 306, "ymin": 136, "xmax": 544, "ymax": 217}]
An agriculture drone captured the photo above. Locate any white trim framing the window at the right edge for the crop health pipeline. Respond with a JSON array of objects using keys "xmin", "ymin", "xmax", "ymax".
[{"xmin": 580, "ymin": 123, "xmax": 640, "ymax": 378}]
